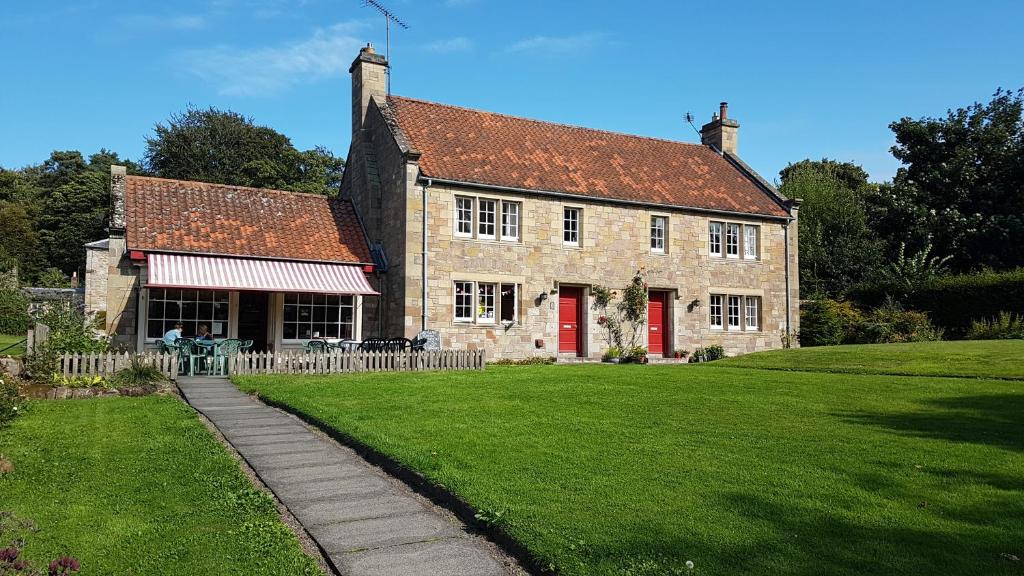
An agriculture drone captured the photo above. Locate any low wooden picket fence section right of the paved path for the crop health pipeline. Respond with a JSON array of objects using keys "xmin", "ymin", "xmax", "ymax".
[{"xmin": 228, "ymin": 349, "xmax": 486, "ymax": 374}]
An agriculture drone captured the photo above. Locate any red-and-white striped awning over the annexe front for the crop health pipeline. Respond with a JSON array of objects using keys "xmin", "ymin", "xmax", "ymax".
[{"xmin": 146, "ymin": 253, "xmax": 378, "ymax": 294}]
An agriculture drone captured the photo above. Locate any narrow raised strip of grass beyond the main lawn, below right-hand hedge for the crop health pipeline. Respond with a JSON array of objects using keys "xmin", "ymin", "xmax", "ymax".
[{"xmin": 720, "ymin": 340, "xmax": 1024, "ymax": 379}]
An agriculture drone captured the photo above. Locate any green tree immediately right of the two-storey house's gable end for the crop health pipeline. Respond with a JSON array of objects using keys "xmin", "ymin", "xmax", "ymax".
[{"xmin": 779, "ymin": 159, "xmax": 882, "ymax": 295}]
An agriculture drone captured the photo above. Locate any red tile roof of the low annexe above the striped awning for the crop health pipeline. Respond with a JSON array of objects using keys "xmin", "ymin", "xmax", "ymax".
[{"xmin": 125, "ymin": 176, "xmax": 373, "ymax": 263}]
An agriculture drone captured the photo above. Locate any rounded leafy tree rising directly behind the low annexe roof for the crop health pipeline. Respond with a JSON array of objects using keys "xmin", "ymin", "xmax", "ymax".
[{"xmin": 145, "ymin": 103, "xmax": 344, "ymax": 194}]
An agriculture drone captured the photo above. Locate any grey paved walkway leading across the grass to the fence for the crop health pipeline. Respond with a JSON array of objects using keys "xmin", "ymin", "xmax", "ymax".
[{"xmin": 178, "ymin": 377, "xmax": 508, "ymax": 576}]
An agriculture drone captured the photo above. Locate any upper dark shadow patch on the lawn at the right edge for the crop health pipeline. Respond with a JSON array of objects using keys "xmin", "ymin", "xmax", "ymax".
[{"xmin": 837, "ymin": 394, "xmax": 1024, "ymax": 451}]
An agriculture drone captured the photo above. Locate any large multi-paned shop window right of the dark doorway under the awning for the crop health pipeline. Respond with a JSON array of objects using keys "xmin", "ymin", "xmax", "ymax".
[{"xmin": 282, "ymin": 293, "xmax": 355, "ymax": 340}]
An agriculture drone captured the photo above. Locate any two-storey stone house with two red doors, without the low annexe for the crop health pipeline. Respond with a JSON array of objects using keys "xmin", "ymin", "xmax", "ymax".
[{"xmin": 341, "ymin": 46, "xmax": 799, "ymax": 358}]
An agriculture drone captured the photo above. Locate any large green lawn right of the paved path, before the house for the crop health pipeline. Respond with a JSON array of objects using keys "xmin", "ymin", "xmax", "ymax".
[{"xmin": 236, "ymin": 340, "xmax": 1024, "ymax": 576}]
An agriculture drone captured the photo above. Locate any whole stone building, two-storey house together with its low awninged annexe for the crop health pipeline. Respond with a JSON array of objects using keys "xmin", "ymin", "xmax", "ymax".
[{"xmin": 86, "ymin": 46, "xmax": 800, "ymax": 358}]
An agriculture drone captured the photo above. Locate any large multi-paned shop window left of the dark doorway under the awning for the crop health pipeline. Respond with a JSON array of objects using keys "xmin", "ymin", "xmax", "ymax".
[{"xmin": 145, "ymin": 288, "xmax": 228, "ymax": 338}]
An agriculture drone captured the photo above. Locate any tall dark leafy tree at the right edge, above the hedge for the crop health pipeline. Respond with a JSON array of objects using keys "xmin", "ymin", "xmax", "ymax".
[{"xmin": 872, "ymin": 88, "xmax": 1024, "ymax": 272}]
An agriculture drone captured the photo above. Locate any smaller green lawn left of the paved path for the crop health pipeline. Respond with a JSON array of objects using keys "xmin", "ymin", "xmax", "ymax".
[{"xmin": 0, "ymin": 396, "xmax": 322, "ymax": 575}]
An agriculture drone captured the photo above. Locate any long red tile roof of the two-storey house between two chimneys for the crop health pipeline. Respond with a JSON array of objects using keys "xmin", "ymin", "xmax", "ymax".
[{"xmin": 386, "ymin": 96, "xmax": 788, "ymax": 216}]
